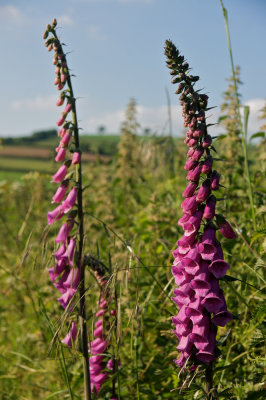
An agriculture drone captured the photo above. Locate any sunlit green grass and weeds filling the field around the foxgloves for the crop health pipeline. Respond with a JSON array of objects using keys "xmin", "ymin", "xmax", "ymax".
[{"xmin": 0, "ymin": 127, "xmax": 265, "ymax": 400}]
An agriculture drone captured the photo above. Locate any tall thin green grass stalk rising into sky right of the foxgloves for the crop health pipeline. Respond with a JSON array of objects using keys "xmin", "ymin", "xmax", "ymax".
[{"xmin": 220, "ymin": 0, "xmax": 257, "ymax": 231}]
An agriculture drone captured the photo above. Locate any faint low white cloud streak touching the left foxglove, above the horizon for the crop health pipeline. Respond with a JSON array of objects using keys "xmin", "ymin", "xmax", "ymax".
[{"xmin": 11, "ymin": 94, "xmax": 57, "ymax": 111}]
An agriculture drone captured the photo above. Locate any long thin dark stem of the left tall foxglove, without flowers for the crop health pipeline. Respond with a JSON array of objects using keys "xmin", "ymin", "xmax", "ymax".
[{"xmin": 54, "ymin": 31, "xmax": 91, "ymax": 400}]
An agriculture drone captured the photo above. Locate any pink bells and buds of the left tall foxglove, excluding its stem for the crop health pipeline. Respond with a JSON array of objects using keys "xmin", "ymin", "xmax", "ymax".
[{"xmin": 43, "ymin": 19, "xmax": 81, "ymax": 347}]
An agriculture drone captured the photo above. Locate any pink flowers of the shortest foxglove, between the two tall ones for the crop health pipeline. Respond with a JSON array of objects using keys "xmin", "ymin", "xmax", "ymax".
[{"xmin": 89, "ymin": 271, "xmax": 117, "ymax": 393}]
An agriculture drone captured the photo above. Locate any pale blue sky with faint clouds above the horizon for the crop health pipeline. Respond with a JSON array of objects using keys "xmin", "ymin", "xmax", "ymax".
[{"xmin": 0, "ymin": 0, "xmax": 266, "ymax": 136}]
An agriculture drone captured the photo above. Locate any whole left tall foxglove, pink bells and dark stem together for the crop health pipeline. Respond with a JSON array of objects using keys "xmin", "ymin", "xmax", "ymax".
[{"xmin": 43, "ymin": 19, "xmax": 91, "ymax": 400}]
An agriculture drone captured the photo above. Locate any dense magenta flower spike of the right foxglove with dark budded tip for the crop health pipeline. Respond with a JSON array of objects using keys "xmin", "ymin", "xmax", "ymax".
[{"xmin": 165, "ymin": 41, "xmax": 236, "ymax": 370}]
